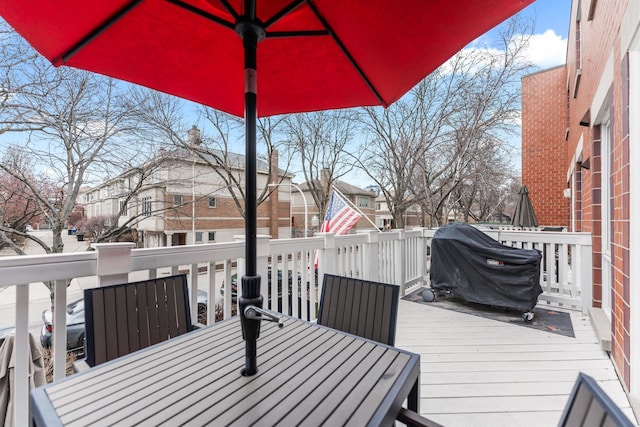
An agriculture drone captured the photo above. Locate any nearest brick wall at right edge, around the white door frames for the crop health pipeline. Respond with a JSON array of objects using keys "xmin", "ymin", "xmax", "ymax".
[{"xmin": 552, "ymin": 0, "xmax": 640, "ymax": 389}]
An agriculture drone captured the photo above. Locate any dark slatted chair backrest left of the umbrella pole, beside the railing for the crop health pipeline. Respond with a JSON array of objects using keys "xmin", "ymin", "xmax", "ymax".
[{"xmin": 84, "ymin": 274, "xmax": 193, "ymax": 366}]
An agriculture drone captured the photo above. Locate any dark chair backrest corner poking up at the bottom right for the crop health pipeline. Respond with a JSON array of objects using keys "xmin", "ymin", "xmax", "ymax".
[{"xmin": 558, "ymin": 372, "xmax": 635, "ymax": 427}]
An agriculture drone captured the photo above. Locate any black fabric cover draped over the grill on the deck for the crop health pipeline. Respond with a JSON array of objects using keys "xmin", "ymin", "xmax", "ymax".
[{"xmin": 431, "ymin": 223, "xmax": 542, "ymax": 312}]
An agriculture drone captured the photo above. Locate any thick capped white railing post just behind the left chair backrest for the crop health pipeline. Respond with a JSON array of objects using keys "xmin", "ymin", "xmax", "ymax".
[{"xmin": 91, "ymin": 242, "xmax": 135, "ymax": 286}]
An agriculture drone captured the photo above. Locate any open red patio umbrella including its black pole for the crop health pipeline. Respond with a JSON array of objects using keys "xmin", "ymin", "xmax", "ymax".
[{"xmin": 0, "ymin": 0, "xmax": 533, "ymax": 375}]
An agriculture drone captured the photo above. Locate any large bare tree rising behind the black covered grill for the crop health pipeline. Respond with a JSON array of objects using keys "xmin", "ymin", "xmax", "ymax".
[{"xmin": 360, "ymin": 17, "xmax": 532, "ymax": 226}]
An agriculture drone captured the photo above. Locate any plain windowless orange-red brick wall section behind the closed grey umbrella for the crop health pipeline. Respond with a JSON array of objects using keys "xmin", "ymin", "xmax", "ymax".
[{"xmin": 522, "ymin": 66, "xmax": 569, "ymax": 227}]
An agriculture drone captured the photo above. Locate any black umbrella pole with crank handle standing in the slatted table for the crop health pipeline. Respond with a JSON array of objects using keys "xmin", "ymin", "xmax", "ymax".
[{"xmin": 238, "ymin": 16, "xmax": 263, "ymax": 376}]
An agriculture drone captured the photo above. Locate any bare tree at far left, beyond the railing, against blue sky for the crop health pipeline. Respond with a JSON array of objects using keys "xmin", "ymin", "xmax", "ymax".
[{"xmin": 0, "ymin": 28, "xmax": 148, "ymax": 253}]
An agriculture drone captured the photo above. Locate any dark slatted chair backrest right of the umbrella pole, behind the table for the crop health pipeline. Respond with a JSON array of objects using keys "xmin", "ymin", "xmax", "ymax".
[{"xmin": 318, "ymin": 274, "xmax": 400, "ymax": 345}]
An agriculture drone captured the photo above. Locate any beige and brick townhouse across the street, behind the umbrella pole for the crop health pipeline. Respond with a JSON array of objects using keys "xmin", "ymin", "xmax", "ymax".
[{"xmin": 84, "ymin": 129, "xmax": 291, "ymax": 247}]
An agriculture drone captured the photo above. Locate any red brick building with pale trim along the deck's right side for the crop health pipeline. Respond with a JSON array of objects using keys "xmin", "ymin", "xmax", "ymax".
[{"xmin": 522, "ymin": 0, "xmax": 640, "ymax": 411}]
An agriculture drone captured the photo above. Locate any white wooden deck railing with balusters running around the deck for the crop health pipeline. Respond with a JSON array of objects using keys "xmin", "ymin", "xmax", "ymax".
[{"xmin": 0, "ymin": 229, "xmax": 592, "ymax": 425}]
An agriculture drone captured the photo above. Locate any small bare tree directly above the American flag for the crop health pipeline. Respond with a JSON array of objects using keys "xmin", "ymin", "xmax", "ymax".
[{"xmin": 286, "ymin": 109, "xmax": 358, "ymax": 216}]
